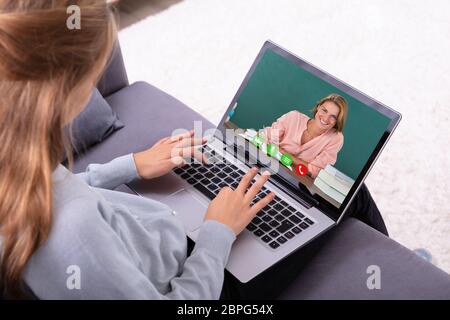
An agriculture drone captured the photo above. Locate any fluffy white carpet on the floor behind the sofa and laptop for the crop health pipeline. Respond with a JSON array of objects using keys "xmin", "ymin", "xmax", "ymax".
[{"xmin": 120, "ymin": 0, "xmax": 450, "ymax": 272}]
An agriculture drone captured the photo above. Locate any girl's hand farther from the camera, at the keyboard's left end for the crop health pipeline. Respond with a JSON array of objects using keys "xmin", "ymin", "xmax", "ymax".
[{"xmin": 133, "ymin": 130, "xmax": 206, "ymax": 179}]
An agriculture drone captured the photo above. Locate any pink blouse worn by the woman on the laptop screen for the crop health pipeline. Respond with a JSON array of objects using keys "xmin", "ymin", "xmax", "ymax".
[{"xmin": 264, "ymin": 111, "xmax": 344, "ymax": 177}]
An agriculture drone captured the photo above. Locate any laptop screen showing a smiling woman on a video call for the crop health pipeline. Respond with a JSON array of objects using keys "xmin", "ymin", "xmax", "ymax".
[{"xmin": 215, "ymin": 42, "xmax": 400, "ymax": 220}]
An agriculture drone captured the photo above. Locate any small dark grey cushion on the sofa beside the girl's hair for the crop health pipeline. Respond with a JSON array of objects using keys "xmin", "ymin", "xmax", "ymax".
[{"xmin": 66, "ymin": 88, "xmax": 124, "ymax": 153}]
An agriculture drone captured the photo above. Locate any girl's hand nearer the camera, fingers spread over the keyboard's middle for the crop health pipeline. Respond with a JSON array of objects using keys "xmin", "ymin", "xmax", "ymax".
[{"xmin": 205, "ymin": 168, "xmax": 275, "ymax": 235}]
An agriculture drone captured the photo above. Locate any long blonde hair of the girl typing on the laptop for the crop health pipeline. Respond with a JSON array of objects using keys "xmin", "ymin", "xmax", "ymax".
[{"xmin": 0, "ymin": 0, "xmax": 116, "ymax": 297}]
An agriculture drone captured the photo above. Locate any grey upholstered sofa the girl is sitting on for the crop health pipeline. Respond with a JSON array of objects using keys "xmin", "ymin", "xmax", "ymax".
[{"xmin": 73, "ymin": 43, "xmax": 450, "ymax": 299}]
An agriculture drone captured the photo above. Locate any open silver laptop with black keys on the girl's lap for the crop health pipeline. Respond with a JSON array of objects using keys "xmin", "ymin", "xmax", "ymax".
[{"xmin": 129, "ymin": 41, "xmax": 401, "ymax": 283}]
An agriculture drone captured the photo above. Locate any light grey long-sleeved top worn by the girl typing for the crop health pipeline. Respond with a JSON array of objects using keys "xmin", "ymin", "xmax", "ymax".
[{"xmin": 24, "ymin": 154, "xmax": 235, "ymax": 299}]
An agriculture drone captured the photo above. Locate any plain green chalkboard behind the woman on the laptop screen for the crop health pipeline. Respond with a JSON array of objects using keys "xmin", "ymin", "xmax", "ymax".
[{"xmin": 230, "ymin": 49, "xmax": 390, "ymax": 179}]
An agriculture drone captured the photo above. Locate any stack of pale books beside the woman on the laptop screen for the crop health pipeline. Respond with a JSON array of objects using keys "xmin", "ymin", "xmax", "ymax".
[{"xmin": 314, "ymin": 165, "xmax": 355, "ymax": 203}]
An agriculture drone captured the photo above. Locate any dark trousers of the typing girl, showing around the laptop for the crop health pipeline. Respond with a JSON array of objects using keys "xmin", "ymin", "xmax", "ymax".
[{"xmin": 188, "ymin": 184, "xmax": 388, "ymax": 300}]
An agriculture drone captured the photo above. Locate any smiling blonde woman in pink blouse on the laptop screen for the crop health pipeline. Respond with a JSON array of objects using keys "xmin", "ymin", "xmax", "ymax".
[{"xmin": 264, "ymin": 94, "xmax": 348, "ymax": 177}]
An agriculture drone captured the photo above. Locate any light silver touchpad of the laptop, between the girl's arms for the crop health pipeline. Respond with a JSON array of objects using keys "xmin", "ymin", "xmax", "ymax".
[{"xmin": 162, "ymin": 189, "xmax": 207, "ymax": 232}]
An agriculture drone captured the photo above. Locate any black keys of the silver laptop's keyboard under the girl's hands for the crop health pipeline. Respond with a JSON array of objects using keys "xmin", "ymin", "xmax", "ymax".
[{"xmin": 174, "ymin": 146, "xmax": 314, "ymax": 249}]
